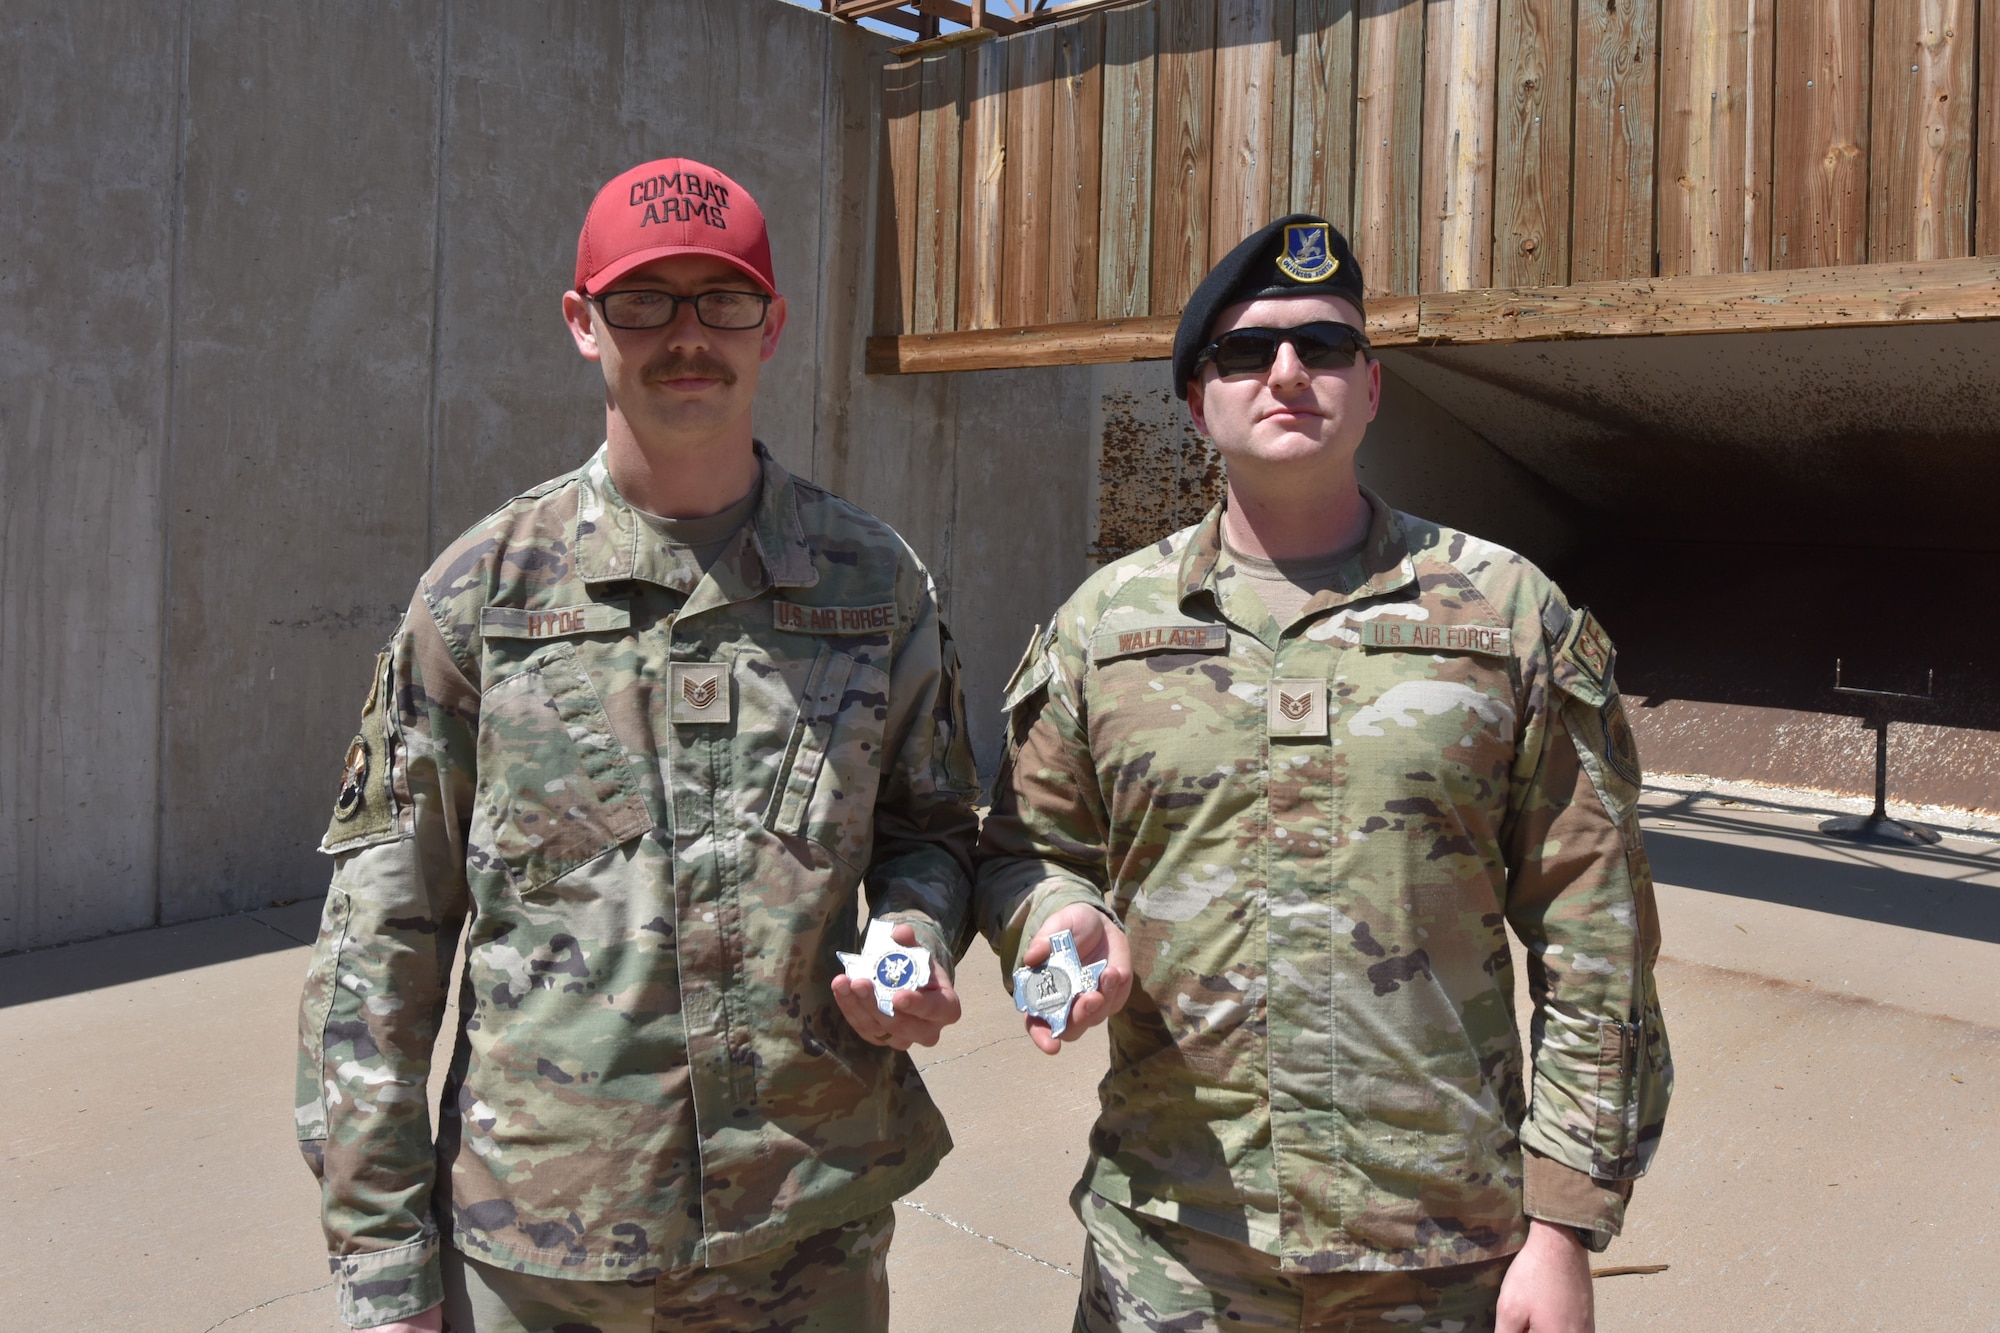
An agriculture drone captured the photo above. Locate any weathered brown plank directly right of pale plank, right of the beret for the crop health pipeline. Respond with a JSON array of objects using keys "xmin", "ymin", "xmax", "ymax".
[{"xmin": 1492, "ymin": 0, "xmax": 1590, "ymax": 286}]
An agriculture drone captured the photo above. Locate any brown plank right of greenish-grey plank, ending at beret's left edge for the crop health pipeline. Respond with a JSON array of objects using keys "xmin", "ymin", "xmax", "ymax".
[{"xmin": 1152, "ymin": 0, "xmax": 1216, "ymax": 314}]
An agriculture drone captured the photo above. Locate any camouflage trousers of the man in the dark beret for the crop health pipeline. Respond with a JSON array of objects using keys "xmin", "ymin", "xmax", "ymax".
[{"xmin": 1072, "ymin": 1189, "xmax": 1512, "ymax": 1333}]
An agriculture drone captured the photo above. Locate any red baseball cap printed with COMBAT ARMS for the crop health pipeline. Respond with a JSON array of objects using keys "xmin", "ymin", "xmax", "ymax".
[{"xmin": 576, "ymin": 158, "xmax": 778, "ymax": 296}]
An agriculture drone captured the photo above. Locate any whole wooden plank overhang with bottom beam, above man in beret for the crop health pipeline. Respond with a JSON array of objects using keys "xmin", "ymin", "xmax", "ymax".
[{"xmin": 868, "ymin": 0, "xmax": 2000, "ymax": 372}]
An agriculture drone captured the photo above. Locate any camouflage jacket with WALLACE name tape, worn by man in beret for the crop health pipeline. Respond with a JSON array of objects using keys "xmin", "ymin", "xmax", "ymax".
[{"xmin": 978, "ymin": 494, "xmax": 1672, "ymax": 1271}]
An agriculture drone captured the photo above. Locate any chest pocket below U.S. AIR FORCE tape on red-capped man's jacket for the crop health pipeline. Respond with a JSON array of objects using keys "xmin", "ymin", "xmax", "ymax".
[{"xmin": 764, "ymin": 644, "xmax": 888, "ymax": 869}]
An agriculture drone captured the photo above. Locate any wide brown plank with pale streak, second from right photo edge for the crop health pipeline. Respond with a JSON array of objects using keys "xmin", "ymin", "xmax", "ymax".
[{"xmin": 1868, "ymin": 0, "xmax": 1978, "ymax": 264}]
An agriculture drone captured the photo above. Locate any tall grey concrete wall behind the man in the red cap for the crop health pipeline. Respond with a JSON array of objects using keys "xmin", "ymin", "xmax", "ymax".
[{"xmin": 0, "ymin": 0, "xmax": 1092, "ymax": 953}]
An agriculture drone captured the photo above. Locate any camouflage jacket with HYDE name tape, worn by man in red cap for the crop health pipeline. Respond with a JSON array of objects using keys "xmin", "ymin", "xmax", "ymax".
[{"xmin": 298, "ymin": 446, "xmax": 978, "ymax": 1325}]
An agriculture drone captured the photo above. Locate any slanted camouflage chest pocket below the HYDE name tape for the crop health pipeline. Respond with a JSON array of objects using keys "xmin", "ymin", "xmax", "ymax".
[{"xmin": 470, "ymin": 644, "xmax": 652, "ymax": 893}]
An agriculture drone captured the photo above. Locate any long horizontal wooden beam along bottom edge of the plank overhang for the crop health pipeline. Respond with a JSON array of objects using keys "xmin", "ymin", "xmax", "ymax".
[{"xmin": 868, "ymin": 256, "xmax": 2000, "ymax": 374}]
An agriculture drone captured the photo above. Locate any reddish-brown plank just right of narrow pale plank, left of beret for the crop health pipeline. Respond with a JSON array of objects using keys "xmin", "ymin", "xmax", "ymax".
[{"xmin": 1000, "ymin": 28, "xmax": 1056, "ymax": 328}]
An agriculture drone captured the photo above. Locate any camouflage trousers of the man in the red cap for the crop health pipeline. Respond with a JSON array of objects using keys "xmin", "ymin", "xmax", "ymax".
[{"xmin": 444, "ymin": 1207, "xmax": 896, "ymax": 1333}]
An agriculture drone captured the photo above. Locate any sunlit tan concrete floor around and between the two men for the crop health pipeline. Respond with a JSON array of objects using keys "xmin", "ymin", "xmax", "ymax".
[{"xmin": 0, "ymin": 793, "xmax": 2000, "ymax": 1333}]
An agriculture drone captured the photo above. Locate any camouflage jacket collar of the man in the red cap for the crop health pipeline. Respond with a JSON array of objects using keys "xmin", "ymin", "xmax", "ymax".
[{"xmin": 570, "ymin": 440, "xmax": 820, "ymax": 610}]
